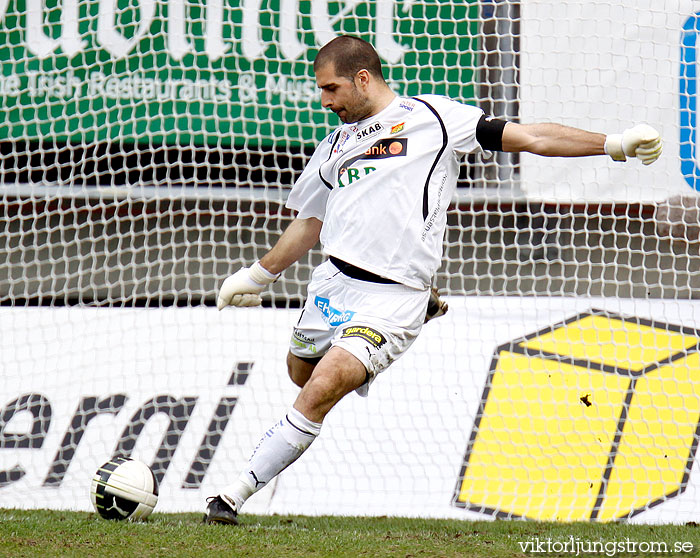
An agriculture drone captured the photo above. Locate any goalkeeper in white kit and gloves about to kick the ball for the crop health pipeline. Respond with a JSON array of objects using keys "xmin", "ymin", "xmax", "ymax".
[{"xmin": 205, "ymin": 36, "xmax": 661, "ymax": 524}]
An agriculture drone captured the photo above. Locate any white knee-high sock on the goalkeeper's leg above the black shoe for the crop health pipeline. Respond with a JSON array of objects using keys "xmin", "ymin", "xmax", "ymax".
[{"xmin": 220, "ymin": 407, "xmax": 321, "ymax": 511}]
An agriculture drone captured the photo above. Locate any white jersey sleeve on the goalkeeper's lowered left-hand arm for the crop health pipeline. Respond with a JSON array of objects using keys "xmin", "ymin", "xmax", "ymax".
[{"xmin": 285, "ymin": 132, "xmax": 338, "ymax": 221}]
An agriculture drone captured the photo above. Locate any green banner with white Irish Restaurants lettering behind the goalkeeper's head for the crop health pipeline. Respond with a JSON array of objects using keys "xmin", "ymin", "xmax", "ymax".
[{"xmin": 0, "ymin": 0, "xmax": 478, "ymax": 146}]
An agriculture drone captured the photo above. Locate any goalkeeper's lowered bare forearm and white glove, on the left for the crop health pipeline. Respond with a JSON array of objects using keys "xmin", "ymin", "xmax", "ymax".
[{"xmin": 216, "ymin": 217, "xmax": 323, "ymax": 310}]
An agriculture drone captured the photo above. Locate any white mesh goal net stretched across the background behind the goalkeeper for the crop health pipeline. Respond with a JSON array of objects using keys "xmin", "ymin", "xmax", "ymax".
[{"xmin": 0, "ymin": 0, "xmax": 700, "ymax": 522}]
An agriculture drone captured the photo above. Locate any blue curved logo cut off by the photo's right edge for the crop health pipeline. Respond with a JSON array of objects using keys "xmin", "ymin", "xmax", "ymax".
[{"xmin": 680, "ymin": 12, "xmax": 700, "ymax": 190}]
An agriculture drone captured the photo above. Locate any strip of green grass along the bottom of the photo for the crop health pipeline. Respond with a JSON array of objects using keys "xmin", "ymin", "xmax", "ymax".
[{"xmin": 0, "ymin": 510, "xmax": 700, "ymax": 558}]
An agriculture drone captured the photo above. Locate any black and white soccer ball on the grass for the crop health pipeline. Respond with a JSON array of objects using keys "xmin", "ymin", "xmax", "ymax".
[{"xmin": 90, "ymin": 457, "xmax": 158, "ymax": 520}]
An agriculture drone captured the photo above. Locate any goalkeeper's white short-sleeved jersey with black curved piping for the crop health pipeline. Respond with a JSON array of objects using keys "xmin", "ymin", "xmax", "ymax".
[{"xmin": 287, "ymin": 95, "xmax": 483, "ymax": 289}]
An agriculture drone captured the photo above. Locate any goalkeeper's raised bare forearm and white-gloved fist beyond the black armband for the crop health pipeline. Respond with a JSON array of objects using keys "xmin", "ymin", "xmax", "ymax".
[{"xmin": 502, "ymin": 122, "xmax": 662, "ymax": 165}]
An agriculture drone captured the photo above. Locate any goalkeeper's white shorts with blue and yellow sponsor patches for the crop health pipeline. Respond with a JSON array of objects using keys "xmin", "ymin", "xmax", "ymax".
[{"xmin": 290, "ymin": 261, "xmax": 430, "ymax": 396}]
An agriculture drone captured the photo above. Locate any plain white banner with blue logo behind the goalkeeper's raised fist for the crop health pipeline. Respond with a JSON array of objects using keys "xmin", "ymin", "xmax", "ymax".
[{"xmin": 520, "ymin": 0, "xmax": 700, "ymax": 203}]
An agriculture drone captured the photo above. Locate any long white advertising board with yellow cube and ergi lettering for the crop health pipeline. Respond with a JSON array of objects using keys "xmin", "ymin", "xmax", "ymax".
[{"xmin": 0, "ymin": 297, "xmax": 700, "ymax": 523}]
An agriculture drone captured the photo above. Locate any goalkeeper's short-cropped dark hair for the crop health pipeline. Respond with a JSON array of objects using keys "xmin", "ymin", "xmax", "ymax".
[{"xmin": 314, "ymin": 35, "xmax": 384, "ymax": 81}]
